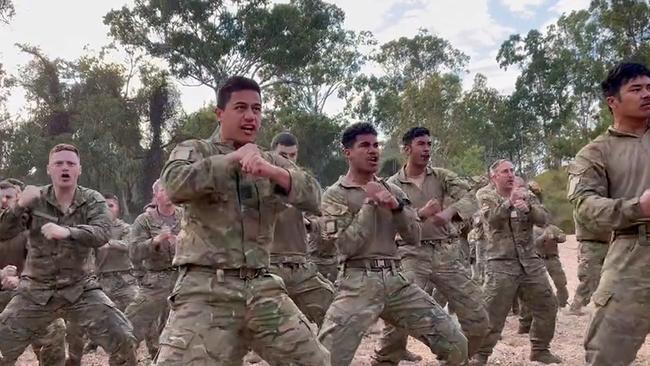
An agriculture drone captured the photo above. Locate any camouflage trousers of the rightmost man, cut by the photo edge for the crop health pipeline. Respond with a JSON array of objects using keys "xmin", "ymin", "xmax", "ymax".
[{"xmin": 584, "ymin": 236, "xmax": 650, "ymax": 366}]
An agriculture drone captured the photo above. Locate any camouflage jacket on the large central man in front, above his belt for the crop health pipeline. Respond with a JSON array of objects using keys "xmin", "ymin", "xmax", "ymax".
[{"xmin": 162, "ymin": 139, "xmax": 320, "ymax": 268}]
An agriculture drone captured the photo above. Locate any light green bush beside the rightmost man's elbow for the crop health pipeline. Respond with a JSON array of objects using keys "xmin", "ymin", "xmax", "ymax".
[{"xmin": 534, "ymin": 169, "xmax": 575, "ymax": 233}]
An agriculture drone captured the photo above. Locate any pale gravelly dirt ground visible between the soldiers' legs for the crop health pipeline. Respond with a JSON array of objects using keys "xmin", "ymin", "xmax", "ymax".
[{"xmin": 13, "ymin": 236, "xmax": 650, "ymax": 366}]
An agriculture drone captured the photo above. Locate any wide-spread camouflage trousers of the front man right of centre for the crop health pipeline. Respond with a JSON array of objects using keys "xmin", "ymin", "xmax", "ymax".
[{"xmin": 319, "ymin": 268, "xmax": 467, "ymax": 366}]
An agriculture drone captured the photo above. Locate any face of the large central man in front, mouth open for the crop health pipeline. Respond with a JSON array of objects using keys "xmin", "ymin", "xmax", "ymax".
[{"xmin": 217, "ymin": 90, "xmax": 262, "ymax": 145}]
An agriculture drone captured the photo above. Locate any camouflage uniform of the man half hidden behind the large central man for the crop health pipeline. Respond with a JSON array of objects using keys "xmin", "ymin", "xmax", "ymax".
[{"xmin": 270, "ymin": 206, "xmax": 334, "ymax": 326}]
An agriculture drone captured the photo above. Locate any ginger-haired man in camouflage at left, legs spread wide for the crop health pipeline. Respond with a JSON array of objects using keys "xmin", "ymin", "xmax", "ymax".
[{"xmin": 0, "ymin": 144, "xmax": 136, "ymax": 365}]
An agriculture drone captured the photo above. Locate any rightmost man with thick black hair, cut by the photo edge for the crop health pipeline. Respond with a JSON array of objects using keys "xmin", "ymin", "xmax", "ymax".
[{"xmin": 568, "ymin": 63, "xmax": 650, "ymax": 366}]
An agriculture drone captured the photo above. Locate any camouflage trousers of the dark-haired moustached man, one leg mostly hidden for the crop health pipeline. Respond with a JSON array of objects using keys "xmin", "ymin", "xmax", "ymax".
[{"xmin": 375, "ymin": 242, "xmax": 489, "ymax": 361}]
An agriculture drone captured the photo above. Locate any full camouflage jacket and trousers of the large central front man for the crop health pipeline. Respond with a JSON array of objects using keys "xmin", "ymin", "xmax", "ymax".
[{"xmin": 156, "ymin": 139, "xmax": 329, "ymax": 366}]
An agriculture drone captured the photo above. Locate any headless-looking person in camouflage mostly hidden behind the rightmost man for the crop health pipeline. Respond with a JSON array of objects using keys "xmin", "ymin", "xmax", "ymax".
[{"xmin": 569, "ymin": 212, "xmax": 612, "ymax": 315}]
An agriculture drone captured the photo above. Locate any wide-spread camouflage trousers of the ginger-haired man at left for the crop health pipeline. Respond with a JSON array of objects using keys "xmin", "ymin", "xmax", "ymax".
[{"xmin": 0, "ymin": 289, "xmax": 136, "ymax": 366}]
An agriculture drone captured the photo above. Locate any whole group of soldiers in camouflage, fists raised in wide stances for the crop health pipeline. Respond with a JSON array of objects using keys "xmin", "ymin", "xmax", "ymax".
[{"xmin": 0, "ymin": 64, "xmax": 650, "ymax": 366}]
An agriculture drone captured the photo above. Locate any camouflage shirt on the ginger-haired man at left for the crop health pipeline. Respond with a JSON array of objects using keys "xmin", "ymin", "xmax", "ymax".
[{"xmin": 0, "ymin": 185, "xmax": 111, "ymax": 304}]
